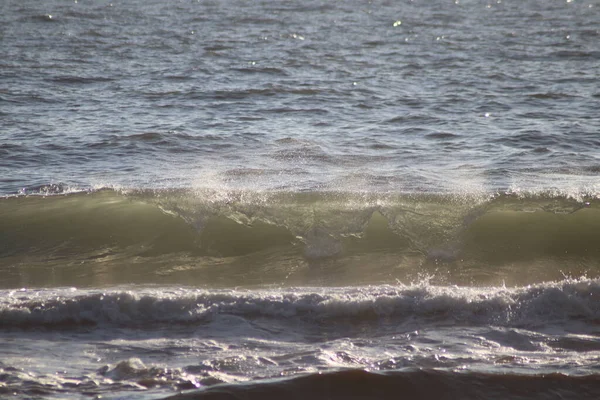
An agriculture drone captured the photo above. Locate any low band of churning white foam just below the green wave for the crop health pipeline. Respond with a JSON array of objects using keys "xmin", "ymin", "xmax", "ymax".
[{"xmin": 0, "ymin": 278, "xmax": 600, "ymax": 328}]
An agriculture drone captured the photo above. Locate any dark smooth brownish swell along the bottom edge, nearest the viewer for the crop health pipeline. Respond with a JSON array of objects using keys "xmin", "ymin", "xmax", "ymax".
[{"xmin": 168, "ymin": 370, "xmax": 600, "ymax": 400}]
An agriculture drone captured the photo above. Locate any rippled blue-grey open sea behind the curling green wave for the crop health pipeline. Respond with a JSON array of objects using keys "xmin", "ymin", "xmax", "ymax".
[{"xmin": 0, "ymin": 0, "xmax": 600, "ymax": 193}]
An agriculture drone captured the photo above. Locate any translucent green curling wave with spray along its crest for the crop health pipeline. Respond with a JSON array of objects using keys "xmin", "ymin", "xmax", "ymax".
[{"xmin": 0, "ymin": 190, "xmax": 600, "ymax": 287}]
